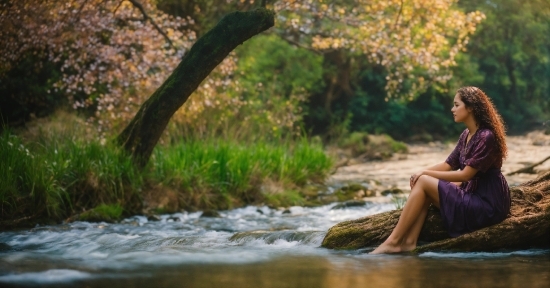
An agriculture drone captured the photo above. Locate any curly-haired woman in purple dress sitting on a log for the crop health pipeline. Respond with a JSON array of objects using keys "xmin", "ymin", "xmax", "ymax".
[{"xmin": 371, "ymin": 87, "xmax": 510, "ymax": 254}]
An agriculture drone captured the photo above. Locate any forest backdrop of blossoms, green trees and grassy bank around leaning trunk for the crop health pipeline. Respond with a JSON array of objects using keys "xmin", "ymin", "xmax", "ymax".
[{"xmin": 0, "ymin": 0, "xmax": 550, "ymax": 225}]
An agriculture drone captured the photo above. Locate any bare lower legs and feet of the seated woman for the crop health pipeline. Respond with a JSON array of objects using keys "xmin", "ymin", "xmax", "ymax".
[{"xmin": 371, "ymin": 175, "xmax": 439, "ymax": 254}]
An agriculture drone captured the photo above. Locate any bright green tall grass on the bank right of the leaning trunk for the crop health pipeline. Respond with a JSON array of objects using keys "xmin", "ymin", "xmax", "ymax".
[{"xmin": 150, "ymin": 139, "xmax": 332, "ymax": 208}]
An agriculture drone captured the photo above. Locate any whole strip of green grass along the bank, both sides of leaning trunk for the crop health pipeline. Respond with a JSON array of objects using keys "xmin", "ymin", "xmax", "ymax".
[{"xmin": 0, "ymin": 125, "xmax": 332, "ymax": 224}]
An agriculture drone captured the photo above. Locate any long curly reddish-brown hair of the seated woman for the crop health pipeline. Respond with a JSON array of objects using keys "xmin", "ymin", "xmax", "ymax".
[{"xmin": 457, "ymin": 86, "xmax": 508, "ymax": 159}]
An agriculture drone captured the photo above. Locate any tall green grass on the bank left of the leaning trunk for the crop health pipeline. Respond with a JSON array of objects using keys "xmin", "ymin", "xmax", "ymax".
[{"xmin": 0, "ymin": 131, "xmax": 142, "ymax": 223}]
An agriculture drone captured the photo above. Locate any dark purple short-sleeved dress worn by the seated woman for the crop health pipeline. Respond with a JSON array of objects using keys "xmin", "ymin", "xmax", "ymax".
[{"xmin": 437, "ymin": 129, "xmax": 511, "ymax": 237}]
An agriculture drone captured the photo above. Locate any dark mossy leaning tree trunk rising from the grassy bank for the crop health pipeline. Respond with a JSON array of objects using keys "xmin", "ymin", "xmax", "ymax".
[{"xmin": 117, "ymin": 8, "xmax": 275, "ymax": 167}]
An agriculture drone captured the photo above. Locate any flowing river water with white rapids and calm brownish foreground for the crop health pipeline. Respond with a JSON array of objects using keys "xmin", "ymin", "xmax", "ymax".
[{"xmin": 0, "ymin": 132, "xmax": 550, "ymax": 288}]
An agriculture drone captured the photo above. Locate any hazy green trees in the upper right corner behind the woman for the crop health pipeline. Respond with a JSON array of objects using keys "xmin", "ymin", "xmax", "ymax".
[{"xmin": 452, "ymin": 0, "xmax": 550, "ymax": 131}]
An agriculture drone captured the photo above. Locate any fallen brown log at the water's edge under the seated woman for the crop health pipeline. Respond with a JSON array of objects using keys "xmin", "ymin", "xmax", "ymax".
[{"xmin": 322, "ymin": 172, "xmax": 550, "ymax": 252}]
